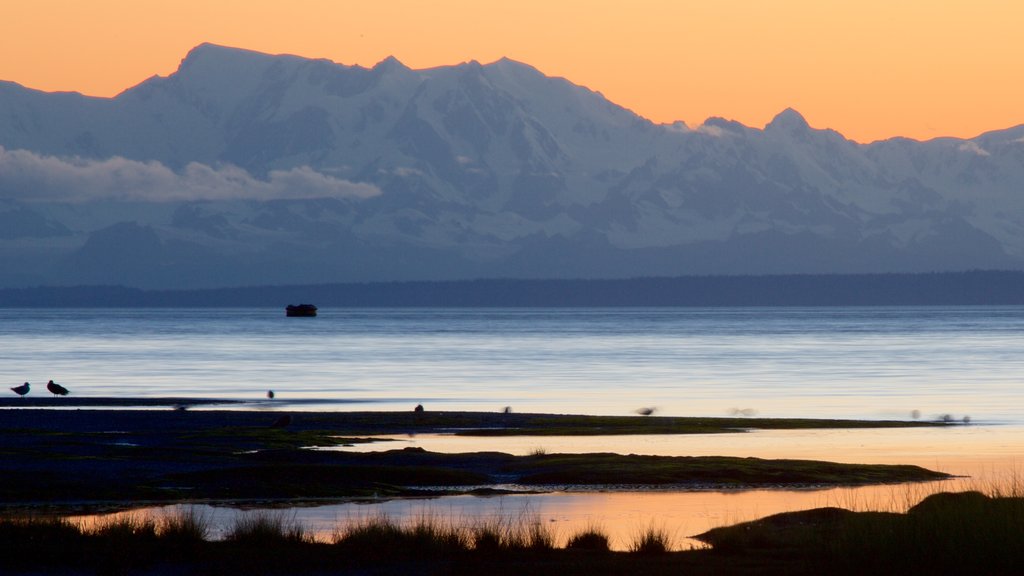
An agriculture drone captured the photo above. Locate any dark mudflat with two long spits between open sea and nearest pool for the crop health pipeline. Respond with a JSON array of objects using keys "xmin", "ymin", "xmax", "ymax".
[{"xmin": 0, "ymin": 399, "xmax": 947, "ymax": 508}]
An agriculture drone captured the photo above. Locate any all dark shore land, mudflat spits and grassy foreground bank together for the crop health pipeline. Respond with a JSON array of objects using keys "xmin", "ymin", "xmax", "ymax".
[{"xmin": 0, "ymin": 403, "xmax": 1024, "ymax": 576}]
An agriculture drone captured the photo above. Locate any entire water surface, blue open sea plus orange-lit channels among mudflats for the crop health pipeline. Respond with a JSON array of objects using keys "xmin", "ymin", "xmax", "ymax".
[{"xmin": 14, "ymin": 307, "xmax": 1024, "ymax": 549}]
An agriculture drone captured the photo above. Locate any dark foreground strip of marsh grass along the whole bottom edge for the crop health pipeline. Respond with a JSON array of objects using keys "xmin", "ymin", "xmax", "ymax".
[{"xmin": 6, "ymin": 479, "xmax": 1024, "ymax": 576}]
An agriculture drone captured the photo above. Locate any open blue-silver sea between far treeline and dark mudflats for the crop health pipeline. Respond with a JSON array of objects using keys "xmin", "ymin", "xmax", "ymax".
[{"xmin": 0, "ymin": 307, "xmax": 1024, "ymax": 424}]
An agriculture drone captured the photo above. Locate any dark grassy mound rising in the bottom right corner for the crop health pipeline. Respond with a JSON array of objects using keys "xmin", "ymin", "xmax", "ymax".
[{"xmin": 705, "ymin": 475, "xmax": 1024, "ymax": 574}]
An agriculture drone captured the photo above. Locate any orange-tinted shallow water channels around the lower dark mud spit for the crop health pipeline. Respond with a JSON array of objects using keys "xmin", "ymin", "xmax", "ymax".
[{"xmin": 72, "ymin": 425, "xmax": 1024, "ymax": 549}]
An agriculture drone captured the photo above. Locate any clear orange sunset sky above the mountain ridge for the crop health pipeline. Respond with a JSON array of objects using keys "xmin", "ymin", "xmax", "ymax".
[{"xmin": 0, "ymin": 0, "xmax": 1024, "ymax": 141}]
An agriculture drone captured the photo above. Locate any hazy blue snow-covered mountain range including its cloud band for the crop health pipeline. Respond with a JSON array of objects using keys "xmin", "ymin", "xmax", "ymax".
[{"xmin": 0, "ymin": 44, "xmax": 1024, "ymax": 288}]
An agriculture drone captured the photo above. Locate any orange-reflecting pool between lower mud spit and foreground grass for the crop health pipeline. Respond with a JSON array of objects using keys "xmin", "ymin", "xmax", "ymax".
[{"xmin": 71, "ymin": 483, "xmax": 983, "ymax": 550}]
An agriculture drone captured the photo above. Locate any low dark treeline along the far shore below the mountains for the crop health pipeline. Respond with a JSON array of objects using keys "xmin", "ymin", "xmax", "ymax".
[{"xmin": 0, "ymin": 271, "xmax": 1024, "ymax": 307}]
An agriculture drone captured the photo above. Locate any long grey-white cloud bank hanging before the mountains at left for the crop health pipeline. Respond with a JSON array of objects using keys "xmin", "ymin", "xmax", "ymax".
[{"xmin": 0, "ymin": 147, "xmax": 381, "ymax": 202}]
